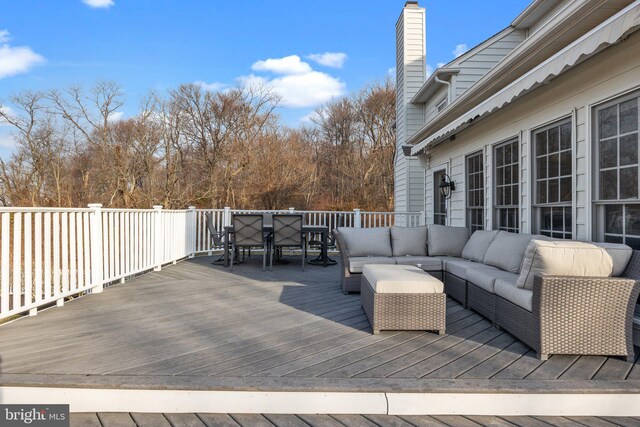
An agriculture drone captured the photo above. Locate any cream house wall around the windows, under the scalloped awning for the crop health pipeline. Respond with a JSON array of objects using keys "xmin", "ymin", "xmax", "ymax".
[{"xmin": 422, "ymin": 32, "xmax": 640, "ymax": 240}]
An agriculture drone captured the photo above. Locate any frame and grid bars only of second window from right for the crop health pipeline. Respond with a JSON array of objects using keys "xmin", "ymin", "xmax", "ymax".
[{"xmin": 529, "ymin": 115, "xmax": 576, "ymax": 239}]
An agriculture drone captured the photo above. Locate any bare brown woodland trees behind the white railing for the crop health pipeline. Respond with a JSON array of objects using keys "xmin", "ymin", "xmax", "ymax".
[{"xmin": 0, "ymin": 80, "xmax": 395, "ymax": 210}]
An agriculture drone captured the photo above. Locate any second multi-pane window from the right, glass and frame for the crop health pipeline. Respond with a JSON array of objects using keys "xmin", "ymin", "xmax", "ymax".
[{"xmin": 533, "ymin": 120, "xmax": 573, "ymax": 239}]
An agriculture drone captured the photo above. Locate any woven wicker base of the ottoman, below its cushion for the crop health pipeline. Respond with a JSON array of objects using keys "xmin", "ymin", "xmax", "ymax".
[{"xmin": 360, "ymin": 276, "xmax": 447, "ymax": 334}]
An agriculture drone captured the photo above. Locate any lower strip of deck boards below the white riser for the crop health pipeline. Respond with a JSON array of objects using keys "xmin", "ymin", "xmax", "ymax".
[{"xmin": 71, "ymin": 413, "xmax": 640, "ymax": 427}]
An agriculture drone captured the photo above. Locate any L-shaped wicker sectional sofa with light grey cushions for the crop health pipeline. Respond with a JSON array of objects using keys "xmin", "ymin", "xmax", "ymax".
[{"xmin": 336, "ymin": 225, "xmax": 640, "ymax": 360}]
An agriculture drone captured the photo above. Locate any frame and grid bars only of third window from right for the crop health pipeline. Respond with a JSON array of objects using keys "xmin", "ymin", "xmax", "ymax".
[{"xmin": 491, "ymin": 136, "xmax": 522, "ymax": 233}]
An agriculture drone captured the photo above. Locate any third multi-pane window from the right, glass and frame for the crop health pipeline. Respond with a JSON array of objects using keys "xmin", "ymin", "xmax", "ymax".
[{"xmin": 493, "ymin": 139, "xmax": 520, "ymax": 233}]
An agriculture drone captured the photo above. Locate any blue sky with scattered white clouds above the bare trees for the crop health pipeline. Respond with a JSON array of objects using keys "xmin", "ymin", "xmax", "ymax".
[{"xmin": 0, "ymin": 0, "xmax": 529, "ymax": 158}]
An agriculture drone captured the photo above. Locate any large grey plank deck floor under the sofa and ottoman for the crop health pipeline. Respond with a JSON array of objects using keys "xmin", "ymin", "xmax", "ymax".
[{"xmin": 0, "ymin": 257, "xmax": 640, "ymax": 414}]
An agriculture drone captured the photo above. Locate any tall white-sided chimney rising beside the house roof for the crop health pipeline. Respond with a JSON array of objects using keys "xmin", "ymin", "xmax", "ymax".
[{"xmin": 394, "ymin": 3, "xmax": 426, "ymax": 217}]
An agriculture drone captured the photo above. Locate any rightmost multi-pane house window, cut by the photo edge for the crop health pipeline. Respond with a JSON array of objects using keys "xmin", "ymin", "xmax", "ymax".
[{"xmin": 593, "ymin": 92, "xmax": 640, "ymax": 249}]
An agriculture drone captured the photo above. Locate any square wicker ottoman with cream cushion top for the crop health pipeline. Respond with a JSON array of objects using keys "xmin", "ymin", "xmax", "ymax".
[{"xmin": 360, "ymin": 264, "xmax": 447, "ymax": 335}]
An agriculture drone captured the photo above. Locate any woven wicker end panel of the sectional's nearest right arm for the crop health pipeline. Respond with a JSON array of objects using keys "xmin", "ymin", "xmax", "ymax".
[{"xmin": 532, "ymin": 276, "xmax": 640, "ymax": 358}]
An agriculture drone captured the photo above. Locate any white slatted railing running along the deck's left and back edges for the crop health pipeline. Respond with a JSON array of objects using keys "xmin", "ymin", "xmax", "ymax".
[{"xmin": 0, "ymin": 204, "xmax": 424, "ymax": 319}]
